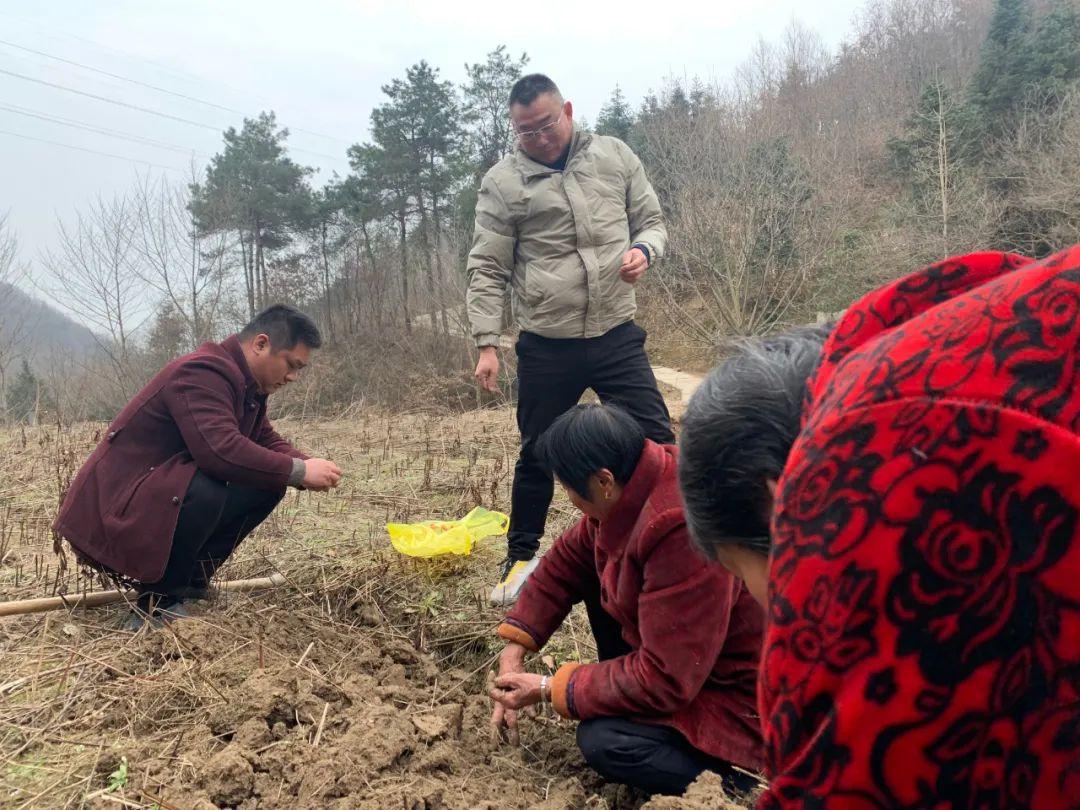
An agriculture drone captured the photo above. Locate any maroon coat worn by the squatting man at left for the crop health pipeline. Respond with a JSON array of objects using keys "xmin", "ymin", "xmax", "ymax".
[{"xmin": 53, "ymin": 336, "xmax": 307, "ymax": 582}]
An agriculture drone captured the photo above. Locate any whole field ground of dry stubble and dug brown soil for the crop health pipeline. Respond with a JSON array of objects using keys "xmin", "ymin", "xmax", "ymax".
[{"xmin": 0, "ymin": 411, "xmax": 751, "ymax": 810}]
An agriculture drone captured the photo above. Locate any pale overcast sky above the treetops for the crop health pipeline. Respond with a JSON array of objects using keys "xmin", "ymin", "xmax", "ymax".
[{"xmin": 0, "ymin": 0, "xmax": 865, "ymax": 276}]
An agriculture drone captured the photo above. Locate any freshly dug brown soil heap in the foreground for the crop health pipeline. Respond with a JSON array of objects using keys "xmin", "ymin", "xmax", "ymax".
[{"xmin": 93, "ymin": 611, "xmax": 611, "ymax": 810}]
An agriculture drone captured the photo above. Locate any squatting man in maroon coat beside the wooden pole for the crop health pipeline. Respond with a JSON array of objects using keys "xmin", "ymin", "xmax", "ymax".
[{"xmin": 53, "ymin": 305, "xmax": 341, "ymax": 630}]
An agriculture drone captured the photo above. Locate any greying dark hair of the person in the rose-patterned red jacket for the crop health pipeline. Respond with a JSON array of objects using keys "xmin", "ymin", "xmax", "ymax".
[{"xmin": 678, "ymin": 324, "xmax": 832, "ymax": 557}]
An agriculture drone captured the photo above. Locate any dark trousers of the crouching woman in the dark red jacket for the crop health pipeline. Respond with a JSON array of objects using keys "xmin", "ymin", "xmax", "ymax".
[{"xmin": 578, "ymin": 582, "xmax": 757, "ymax": 795}]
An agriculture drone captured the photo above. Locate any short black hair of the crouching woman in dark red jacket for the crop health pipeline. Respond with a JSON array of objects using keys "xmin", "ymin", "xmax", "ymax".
[{"xmin": 536, "ymin": 405, "xmax": 645, "ymax": 500}]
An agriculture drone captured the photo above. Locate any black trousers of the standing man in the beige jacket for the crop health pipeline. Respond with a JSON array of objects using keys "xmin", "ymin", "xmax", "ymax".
[{"xmin": 508, "ymin": 321, "xmax": 675, "ymax": 559}]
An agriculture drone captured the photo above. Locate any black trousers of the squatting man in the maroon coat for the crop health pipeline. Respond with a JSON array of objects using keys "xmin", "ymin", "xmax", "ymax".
[{"xmin": 139, "ymin": 471, "xmax": 285, "ymax": 599}]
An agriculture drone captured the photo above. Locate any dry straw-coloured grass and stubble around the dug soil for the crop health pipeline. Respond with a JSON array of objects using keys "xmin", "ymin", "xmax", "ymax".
[{"xmin": 0, "ymin": 411, "xmax": 574, "ymax": 807}]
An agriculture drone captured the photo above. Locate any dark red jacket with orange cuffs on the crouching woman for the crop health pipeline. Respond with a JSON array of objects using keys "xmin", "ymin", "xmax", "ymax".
[{"xmin": 499, "ymin": 442, "xmax": 764, "ymax": 770}]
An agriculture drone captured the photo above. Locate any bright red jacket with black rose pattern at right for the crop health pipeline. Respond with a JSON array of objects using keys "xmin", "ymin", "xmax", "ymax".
[{"xmin": 760, "ymin": 247, "xmax": 1080, "ymax": 810}]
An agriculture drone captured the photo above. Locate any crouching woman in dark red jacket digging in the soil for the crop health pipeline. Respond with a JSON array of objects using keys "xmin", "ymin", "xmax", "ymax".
[{"xmin": 491, "ymin": 405, "xmax": 764, "ymax": 793}]
